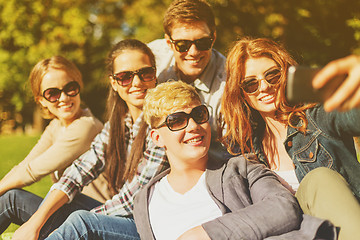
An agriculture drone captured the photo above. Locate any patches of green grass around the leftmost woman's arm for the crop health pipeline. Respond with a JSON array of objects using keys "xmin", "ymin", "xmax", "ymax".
[{"xmin": 0, "ymin": 135, "xmax": 52, "ymax": 235}]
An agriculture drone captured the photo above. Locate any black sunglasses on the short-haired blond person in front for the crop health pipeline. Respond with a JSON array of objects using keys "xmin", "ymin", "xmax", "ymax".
[{"xmin": 157, "ymin": 105, "xmax": 209, "ymax": 131}]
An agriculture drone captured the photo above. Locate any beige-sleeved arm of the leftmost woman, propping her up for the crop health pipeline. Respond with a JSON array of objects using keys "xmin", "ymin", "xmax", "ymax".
[{"xmin": 0, "ymin": 114, "xmax": 101, "ymax": 194}]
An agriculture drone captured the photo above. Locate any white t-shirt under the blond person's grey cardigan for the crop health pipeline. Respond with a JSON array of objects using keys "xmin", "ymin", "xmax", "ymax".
[{"xmin": 149, "ymin": 173, "xmax": 222, "ymax": 240}]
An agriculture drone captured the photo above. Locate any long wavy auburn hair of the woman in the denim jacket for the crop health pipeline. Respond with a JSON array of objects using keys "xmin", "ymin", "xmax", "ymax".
[{"xmin": 220, "ymin": 38, "xmax": 314, "ymax": 154}]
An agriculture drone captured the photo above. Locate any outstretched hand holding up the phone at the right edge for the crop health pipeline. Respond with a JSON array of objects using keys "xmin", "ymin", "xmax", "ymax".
[{"xmin": 313, "ymin": 55, "xmax": 360, "ymax": 112}]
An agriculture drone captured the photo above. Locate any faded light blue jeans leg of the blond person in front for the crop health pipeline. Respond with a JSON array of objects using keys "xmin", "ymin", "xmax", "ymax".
[{"xmin": 46, "ymin": 210, "xmax": 140, "ymax": 240}]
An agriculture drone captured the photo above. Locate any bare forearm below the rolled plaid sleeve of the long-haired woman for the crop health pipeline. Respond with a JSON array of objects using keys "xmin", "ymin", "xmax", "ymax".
[{"xmin": 12, "ymin": 190, "xmax": 68, "ymax": 240}]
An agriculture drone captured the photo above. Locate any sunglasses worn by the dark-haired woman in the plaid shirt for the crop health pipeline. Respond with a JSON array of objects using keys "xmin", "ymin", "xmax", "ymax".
[{"xmin": 111, "ymin": 67, "xmax": 156, "ymax": 86}]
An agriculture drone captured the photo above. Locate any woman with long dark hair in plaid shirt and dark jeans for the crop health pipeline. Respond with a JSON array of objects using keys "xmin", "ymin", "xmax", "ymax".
[{"xmin": 0, "ymin": 39, "xmax": 167, "ymax": 240}]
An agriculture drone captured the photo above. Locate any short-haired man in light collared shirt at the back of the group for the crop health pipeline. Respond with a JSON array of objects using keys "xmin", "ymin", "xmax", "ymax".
[{"xmin": 149, "ymin": 0, "xmax": 226, "ymax": 158}]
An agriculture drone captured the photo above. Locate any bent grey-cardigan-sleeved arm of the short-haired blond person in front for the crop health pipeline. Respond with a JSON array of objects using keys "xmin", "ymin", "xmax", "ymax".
[{"xmin": 202, "ymin": 157, "xmax": 302, "ymax": 239}]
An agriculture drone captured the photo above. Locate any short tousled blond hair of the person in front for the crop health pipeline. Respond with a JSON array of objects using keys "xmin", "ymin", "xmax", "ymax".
[{"xmin": 143, "ymin": 81, "xmax": 201, "ymax": 128}]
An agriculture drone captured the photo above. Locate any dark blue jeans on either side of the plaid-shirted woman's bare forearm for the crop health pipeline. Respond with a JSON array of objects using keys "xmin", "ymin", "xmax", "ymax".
[{"xmin": 0, "ymin": 189, "xmax": 101, "ymax": 239}]
